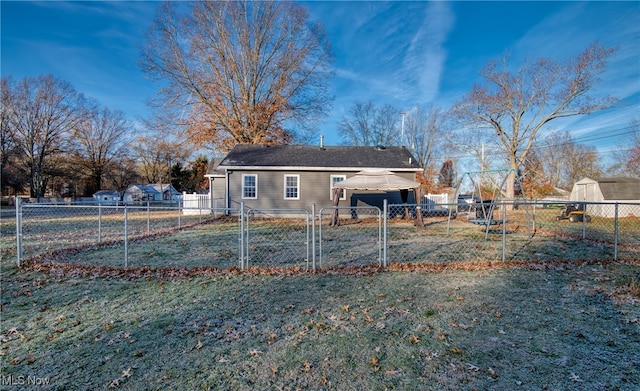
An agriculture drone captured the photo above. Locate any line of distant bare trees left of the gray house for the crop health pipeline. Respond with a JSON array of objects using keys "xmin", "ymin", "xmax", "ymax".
[{"xmin": 0, "ymin": 75, "xmax": 208, "ymax": 198}]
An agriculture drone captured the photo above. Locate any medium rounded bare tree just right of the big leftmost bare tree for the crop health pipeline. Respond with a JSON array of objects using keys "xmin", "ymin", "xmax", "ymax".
[{"xmin": 73, "ymin": 107, "xmax": 133, "ymax": 194}]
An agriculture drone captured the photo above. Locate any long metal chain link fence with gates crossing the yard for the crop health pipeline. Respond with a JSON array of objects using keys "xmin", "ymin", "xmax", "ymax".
[{"xmin": 10, "ymin": 202, "xmax": 640, "ymax": 270}]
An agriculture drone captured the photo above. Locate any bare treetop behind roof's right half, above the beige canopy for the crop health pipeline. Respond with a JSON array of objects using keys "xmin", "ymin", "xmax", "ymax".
[{"xmin": 338, "ymin": 101, "xmax": 400, "ymax": 146}]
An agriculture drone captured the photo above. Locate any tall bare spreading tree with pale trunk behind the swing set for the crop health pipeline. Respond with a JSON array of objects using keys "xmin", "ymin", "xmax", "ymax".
[{"xmin": 453, "ymin": 42, "xmax": 616, "ymax": 198}]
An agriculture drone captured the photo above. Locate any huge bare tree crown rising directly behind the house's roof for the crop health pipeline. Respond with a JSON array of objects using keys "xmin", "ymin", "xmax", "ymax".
[{"xmin": 142, "ymin": 1, "xmax": 332, "ymax": 150}]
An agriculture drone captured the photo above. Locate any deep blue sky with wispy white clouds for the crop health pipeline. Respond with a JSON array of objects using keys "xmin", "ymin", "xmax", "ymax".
[{"xmin": 0, "ymin": 0, "xmax": 640, "ymax": 163}]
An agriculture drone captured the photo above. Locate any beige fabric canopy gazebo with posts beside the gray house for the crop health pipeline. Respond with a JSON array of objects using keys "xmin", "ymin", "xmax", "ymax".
[{"xmin": 331, "ymin": 170, "xmax": 423, "ymax": 226}]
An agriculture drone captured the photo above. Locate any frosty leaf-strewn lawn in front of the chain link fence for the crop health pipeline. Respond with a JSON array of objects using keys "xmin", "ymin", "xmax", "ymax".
[{"xmin": 0, "ymin": 259, "xmax": 640, "ymax": 390}]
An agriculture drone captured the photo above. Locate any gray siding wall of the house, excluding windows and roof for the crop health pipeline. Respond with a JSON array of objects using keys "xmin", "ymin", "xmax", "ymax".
[{"xmin": 228, "ymin": 170, "xmax": 415, "ymax": 210}]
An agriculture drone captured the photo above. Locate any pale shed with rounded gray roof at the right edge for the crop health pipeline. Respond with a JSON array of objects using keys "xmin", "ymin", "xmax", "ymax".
[{"xmin": 569, "ymin": 177, "xmax": 640, "ymax": 217}]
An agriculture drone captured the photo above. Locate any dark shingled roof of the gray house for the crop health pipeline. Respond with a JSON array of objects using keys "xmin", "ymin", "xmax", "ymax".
[{"xmin": 220, "ymin": 144, "xmax": 421, "ymax": 171}]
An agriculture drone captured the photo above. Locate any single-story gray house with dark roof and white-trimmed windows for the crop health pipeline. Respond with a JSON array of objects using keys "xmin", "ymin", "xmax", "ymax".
[{"xmin": 207, "ymin": 144, "xmax": 422, "ymax": 210}]
